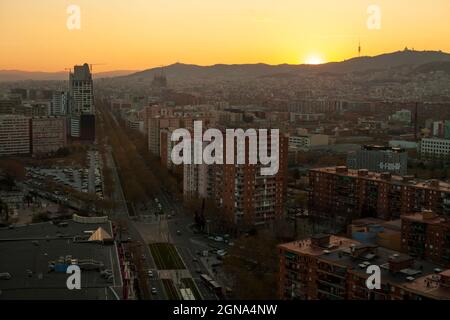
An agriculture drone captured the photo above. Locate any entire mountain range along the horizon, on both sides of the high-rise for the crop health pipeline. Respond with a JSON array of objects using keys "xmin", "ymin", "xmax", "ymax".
[{"xmin": 0, "ymin": 49, "xmax": 450, "ymax": 81}]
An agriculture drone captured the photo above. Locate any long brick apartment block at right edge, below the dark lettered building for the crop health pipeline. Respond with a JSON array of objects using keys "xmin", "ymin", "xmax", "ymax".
[{"xmin": 309, "ymin": 167, "xmax": 450, "ymax": 226}]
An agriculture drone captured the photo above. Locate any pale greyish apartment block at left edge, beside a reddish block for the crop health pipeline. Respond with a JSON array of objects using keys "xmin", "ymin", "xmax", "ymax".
[{"xmin": 0, "ymin": 115, "xmax": 31, "ymax": 157}]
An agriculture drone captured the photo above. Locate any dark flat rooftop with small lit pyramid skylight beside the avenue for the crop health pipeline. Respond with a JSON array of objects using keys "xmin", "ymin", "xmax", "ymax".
[{"xmin": 0, "ymin": 220, "xmax": 122, "ymax": 300}]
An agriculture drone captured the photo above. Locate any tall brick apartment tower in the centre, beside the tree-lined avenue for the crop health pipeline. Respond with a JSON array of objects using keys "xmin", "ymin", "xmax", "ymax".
[{"xmin": 183, "ymin": 129, "xmax": 288, "ymax": 227}]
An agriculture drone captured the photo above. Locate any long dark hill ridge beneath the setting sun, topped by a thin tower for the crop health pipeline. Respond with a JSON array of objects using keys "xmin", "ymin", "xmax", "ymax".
[{"xmin": 126, "ymin": 50, "xmax": 450, "ymax": 80}]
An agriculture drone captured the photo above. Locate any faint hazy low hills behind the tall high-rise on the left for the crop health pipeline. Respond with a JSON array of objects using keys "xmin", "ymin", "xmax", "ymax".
[{"xmin": 0, "ymin": 70, "xmax": 136, "ymax": 82}]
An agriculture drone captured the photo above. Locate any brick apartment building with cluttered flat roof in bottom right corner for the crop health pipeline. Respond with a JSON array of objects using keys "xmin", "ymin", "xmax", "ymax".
[{"xmin": 279, "ymin": 235, "xmax": 450, "ymax": 300}]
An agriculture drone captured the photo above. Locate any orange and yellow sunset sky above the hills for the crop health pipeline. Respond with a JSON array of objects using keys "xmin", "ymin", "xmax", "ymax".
[{"xmin": 0, "ymin": 0, "xmax": 450, "ymax": 72}]
